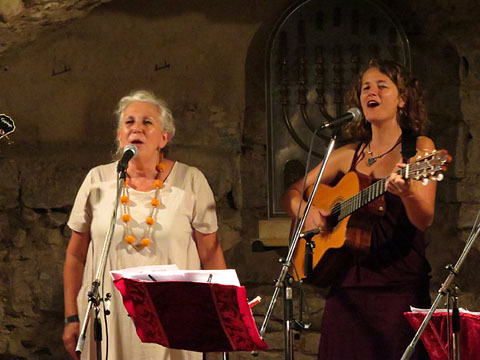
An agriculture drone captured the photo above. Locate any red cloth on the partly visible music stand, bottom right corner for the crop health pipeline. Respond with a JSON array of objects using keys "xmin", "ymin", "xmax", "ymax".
[{"xmin": 404, "ymin": 311, "xmax": 480, "ymax": 360}]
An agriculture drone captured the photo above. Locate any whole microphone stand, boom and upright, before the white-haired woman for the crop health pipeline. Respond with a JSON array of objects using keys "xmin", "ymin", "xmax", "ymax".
[{"xmin": 75, "ymin": 167, "xmax": 127, "ymax": 360}]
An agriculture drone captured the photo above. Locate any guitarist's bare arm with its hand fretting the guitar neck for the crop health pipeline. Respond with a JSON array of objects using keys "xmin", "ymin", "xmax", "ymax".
[{"xmin": 386, "ymin": 136, "xmax": 437, "ymax": 231}]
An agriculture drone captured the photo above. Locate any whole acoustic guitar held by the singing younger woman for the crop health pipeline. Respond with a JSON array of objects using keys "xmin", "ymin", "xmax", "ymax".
[{"xmin": 290, "ymin": 150, "xmax": 452, "ymax": 286}]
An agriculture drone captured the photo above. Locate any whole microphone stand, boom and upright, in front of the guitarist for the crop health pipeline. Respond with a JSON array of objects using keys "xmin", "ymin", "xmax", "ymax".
[{"xmin": 253, "ymin": 131, "xmax": 337, "ymax": 360}]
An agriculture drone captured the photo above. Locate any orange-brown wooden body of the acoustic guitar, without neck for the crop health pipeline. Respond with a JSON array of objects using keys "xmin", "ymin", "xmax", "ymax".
[{"xmin": 292, "ymin": 172, "xmax": 378, "ymax": 287}]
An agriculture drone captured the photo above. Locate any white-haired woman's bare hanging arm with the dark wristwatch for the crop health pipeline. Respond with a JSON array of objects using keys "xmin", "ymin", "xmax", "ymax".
[{"xmin": 63, "ymin": 231, "xmax": 90, "ymax": 359}]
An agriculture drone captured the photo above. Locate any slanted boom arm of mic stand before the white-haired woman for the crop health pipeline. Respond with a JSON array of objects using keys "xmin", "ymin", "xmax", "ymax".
[{"xmin": 75, "ymin": 170, "xmax": 126, "ymax": 359}]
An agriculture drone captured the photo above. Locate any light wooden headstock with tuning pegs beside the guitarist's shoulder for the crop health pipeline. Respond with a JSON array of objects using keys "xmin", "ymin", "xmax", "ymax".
[{"xmin": 408, "ymin": 150, "xmax": 452, "ymax": 184}]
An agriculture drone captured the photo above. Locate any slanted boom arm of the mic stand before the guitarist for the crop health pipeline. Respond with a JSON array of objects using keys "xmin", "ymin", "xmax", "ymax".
[{"xmin": 259, "ymin": 134, "xmax": 336, "ymax": 339}]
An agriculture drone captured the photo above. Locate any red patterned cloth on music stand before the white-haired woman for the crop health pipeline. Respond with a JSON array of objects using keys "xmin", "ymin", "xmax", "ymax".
[{"xmin": 113, "ymin": 278, "xmax": 267, "ymax": 352}]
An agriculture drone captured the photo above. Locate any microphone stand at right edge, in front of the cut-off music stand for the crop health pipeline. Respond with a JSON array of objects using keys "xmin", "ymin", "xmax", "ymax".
[{"xmin": 401, "ymin": 212, "xmax": 480, "ymax": 360}]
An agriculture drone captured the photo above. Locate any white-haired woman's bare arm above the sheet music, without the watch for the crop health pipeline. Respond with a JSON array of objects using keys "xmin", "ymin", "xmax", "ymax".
[{"xmin": 193, "ymin": 229, "xmax": 227, "ymax": 270}]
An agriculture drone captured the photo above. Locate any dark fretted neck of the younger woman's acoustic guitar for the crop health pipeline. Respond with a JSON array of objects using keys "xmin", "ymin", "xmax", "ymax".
[{"xmin": 332, "ymin": 166, "xmax": 409, "ymax": 220}]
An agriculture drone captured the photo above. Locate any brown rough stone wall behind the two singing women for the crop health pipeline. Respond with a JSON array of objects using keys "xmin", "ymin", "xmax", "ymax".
[{"xmin": 0, "ymin": 0, "xmax": 480, "ymax": 359}]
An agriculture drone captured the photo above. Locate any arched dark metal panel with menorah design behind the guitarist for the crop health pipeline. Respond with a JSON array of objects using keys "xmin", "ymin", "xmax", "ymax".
[{"xmin": 266, "ymin": 0, "xmax": 410, "ymax": 216}]
